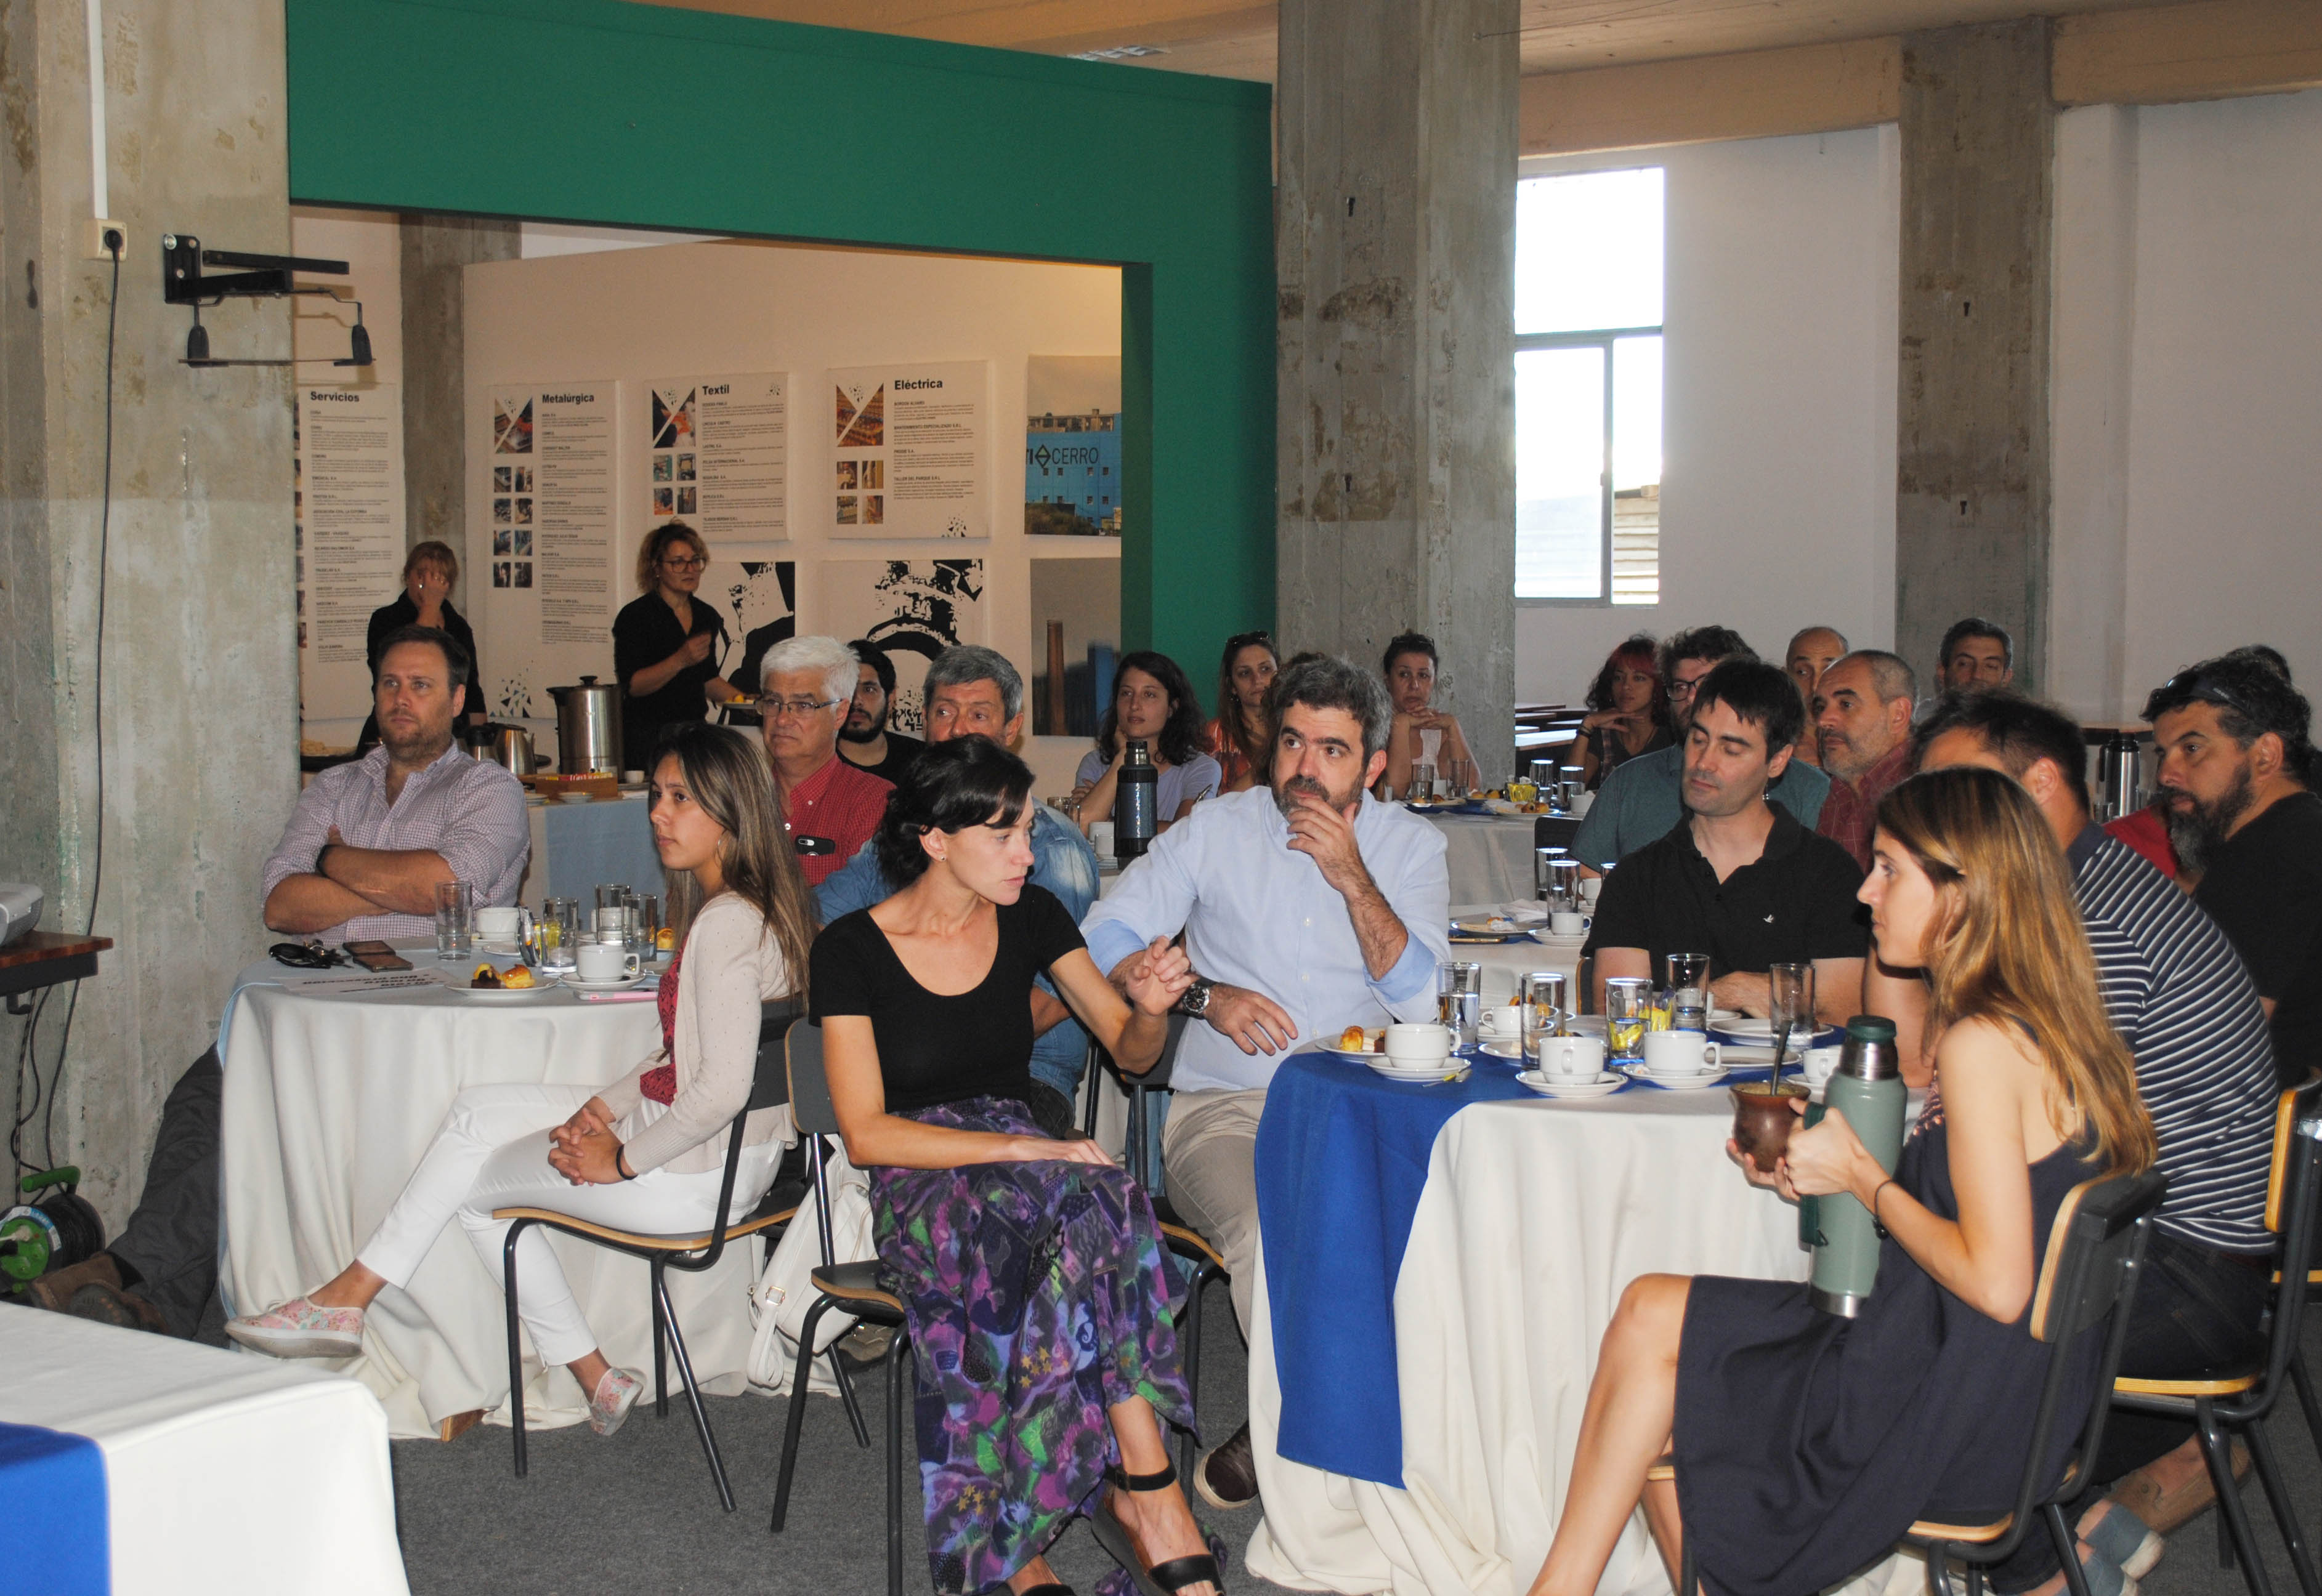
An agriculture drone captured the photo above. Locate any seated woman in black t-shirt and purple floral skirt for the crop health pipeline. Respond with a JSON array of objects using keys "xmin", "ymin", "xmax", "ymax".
[{"xmin": 813, "ymin": 738, "xmax": 1224, "ymax": 1596}]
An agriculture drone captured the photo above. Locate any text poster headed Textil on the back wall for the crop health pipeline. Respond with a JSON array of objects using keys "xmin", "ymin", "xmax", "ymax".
[{"xmin": 631, "ymin": 371, "xmax": 790, "ymax": 550}]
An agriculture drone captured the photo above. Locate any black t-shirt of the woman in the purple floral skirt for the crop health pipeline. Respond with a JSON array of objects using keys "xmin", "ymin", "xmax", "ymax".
[{"xmin": 811, "ymin": 882, "xmax": 1086, "ymax": 1113}]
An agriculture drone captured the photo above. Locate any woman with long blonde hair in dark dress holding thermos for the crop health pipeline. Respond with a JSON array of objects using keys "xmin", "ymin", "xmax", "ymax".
[{"xmin": 1532, "ymin": 768, "xmax": 2155, "ymax": 1596}]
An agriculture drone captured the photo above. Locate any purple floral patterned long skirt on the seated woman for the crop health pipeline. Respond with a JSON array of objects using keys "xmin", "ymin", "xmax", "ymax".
[{"xmin": 871, "ymin": 1097, "xmax": 1194, "ymax": 1591}]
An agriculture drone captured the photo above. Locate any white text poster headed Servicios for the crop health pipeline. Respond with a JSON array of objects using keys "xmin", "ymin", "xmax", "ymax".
[{"xmin": 290, "ymin": 383, "xmax": 404, "ymax": 719}]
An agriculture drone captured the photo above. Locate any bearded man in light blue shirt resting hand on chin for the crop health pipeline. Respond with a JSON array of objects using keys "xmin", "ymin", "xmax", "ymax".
[{"xmin": 1082, "ymin": 659, "xmax": 1439, "ymax": 1508}]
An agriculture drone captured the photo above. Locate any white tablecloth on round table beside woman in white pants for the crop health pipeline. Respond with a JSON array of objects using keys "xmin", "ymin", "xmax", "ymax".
[{"xmin": 223, "ymin": 953, "xmax": 759, "ymax": 1436}]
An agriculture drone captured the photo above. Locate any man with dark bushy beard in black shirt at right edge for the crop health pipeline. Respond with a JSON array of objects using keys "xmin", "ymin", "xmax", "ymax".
[{"xmin": 2145, "ymin": 652, "xmax": 2322, "ymax": 1086}]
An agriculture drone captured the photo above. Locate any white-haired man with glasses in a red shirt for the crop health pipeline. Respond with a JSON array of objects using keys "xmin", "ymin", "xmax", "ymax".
[{"xmin": 757, "ymin": 638, "xmax": 894, "ymax": 886}]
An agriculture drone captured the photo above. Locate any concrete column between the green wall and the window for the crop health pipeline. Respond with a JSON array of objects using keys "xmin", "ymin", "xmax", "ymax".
[{"xmin": 1275, "ymin": 0, "xmax": 1519, "ymax": 782}]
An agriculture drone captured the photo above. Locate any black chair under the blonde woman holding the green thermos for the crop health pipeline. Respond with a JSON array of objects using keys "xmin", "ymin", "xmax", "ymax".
[{"xmin": 1646, "ymin": 1172, "xmax": 2169, "ymax": 1596}]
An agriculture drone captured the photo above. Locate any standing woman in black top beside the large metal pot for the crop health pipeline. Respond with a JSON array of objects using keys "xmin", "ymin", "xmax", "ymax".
[{"xmin": 613, "ymin": 522, "xmax": 738, "ymax": 770}]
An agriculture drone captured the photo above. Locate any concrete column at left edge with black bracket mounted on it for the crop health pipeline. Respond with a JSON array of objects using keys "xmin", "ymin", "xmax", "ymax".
[{"xmin": 0, "ymin": 0, "xmax": 297, "ymax": 1227}]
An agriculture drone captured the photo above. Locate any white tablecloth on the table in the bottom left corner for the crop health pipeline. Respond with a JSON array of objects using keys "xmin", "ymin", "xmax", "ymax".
[{"xmin": 0, "ymin": 1308, "xmax": 407, "ymax": 1596}]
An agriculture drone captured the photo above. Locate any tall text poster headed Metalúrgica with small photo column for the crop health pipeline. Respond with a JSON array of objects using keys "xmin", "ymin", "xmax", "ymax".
[{"xmin": 469, "ymin": 383, "xmax": 629, "ymax": 719}]
